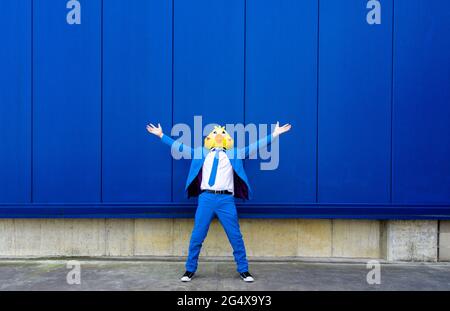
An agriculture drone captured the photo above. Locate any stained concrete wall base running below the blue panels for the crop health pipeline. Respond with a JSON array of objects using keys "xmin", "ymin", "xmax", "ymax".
[{"xmin": 0, "ymin": 219, "xmax": 442, "ymax": 261}]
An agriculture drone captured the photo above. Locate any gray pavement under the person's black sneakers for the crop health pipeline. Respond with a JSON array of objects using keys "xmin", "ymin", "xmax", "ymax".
[{"xmin": 0, "ymin": 259, "xmax": 450, "ymax": 291}]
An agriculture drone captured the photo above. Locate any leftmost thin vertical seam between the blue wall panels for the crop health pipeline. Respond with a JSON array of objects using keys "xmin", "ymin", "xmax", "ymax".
[{"xmin": 30, "ymin": 0, "xmax": 34, "ymax": 203}]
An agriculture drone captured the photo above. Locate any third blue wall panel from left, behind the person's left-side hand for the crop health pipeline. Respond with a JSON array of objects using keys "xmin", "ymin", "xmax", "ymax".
[{"xmin": 102, "ymin": 0, "xmax": 172, "ymax": 202}]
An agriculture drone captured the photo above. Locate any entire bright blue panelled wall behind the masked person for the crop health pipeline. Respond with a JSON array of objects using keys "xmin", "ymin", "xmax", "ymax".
[{"xmin": 0, "ymin": 0, "xmax": 450, "ymax": 219}]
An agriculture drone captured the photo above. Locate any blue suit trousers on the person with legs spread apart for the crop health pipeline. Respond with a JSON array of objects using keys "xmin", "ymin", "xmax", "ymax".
[{"xmin": 186, "ymin": 192, "xmax": 248, "ymax": 273}]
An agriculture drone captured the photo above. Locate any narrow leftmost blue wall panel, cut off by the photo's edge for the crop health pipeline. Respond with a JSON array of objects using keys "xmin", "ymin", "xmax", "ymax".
[{"xmin": 0, "ymin": 0, "xmax": 31, "ymax": 203}]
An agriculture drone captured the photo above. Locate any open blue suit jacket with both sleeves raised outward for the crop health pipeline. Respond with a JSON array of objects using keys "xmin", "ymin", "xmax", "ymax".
[{"xmin": 161, "ymin": 135, "xmax": 272, "ymax": 200}]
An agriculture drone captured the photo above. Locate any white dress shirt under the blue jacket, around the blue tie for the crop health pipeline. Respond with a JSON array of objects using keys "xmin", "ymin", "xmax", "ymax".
[{"xmin": 200, "ymin": 149, "xmax": 234, "ymax": 194}]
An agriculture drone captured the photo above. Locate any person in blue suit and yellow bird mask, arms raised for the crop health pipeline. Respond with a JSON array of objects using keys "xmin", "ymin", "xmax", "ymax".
[{"xmin": 147, "ymin": 122, "xmax": 291, "ymax": 282}]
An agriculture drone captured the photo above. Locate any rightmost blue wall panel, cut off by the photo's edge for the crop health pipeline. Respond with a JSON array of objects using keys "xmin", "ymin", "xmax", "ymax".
[{"xmin": 393, "ymin": 0, "xmax": 450, "ymax": 204}]
